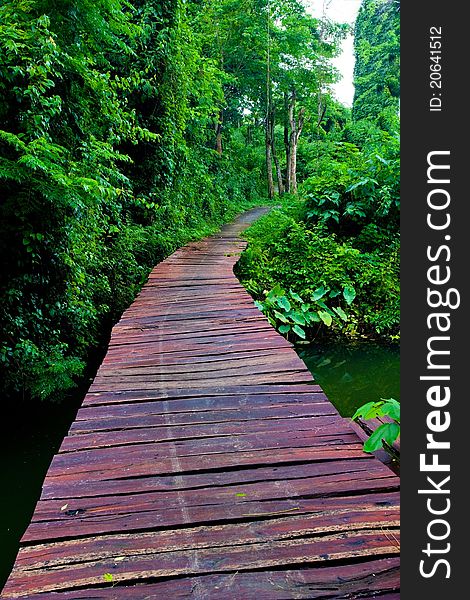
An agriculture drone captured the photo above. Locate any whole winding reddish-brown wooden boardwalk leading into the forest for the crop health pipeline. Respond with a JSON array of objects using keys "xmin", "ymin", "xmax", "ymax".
[{"xmin": 2, "ymin": 210, "xmax": 399, "ymax": 600}]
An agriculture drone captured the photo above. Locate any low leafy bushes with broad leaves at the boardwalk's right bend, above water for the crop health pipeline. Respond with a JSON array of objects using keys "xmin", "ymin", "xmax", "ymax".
[{"xmin": 237, "ymin": 201, "xmax": 400, "ymax": 339}]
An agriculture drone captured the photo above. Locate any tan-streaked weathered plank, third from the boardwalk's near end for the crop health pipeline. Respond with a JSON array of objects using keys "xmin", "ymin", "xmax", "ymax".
[{"xmin": 17, "ymin": 506, "xmax": 398, "ymax": 569}]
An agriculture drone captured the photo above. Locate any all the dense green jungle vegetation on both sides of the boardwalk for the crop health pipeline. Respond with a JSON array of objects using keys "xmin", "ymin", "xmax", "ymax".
[{"xmin": 0, "ymin": 0, "xmax": 399, "ymax": 406}]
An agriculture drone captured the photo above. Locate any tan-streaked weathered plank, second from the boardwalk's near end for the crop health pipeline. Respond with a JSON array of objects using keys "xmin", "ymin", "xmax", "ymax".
[{"xmin": 7, "ymin": 529, "xmax": 398, "ymax": 597}]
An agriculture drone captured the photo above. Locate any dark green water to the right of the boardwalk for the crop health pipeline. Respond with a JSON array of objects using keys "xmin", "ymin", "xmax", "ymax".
[{"xmin": 297, "ymin": 341, "xmax": 400, "ymax": 417}]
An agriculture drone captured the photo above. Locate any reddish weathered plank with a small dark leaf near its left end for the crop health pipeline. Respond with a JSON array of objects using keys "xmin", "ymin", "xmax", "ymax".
[{"xmin": 22, "ymin": 488, "xmax": 398, "ymax": 542}]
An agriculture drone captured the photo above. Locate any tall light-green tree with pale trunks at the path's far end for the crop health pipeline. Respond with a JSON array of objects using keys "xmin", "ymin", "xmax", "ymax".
[{"xmin": 189, "ymin": 0, "xmax": 344, "ymax": 197}]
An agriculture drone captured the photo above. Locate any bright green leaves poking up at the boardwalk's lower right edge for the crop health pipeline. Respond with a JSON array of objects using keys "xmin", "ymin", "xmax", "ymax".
[{"xmin": 352, "ymin": 398, "xmax": 400, "ymax": 452}]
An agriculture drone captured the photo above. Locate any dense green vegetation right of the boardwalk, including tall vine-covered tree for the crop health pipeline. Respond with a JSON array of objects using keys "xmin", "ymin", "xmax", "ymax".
[{"xmin": 238, "ymin": 0, "xmax": 400, "ymax": 341}]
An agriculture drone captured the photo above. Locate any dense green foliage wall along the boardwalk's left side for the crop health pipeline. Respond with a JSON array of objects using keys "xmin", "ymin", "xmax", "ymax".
[{"xmin": 0, "ymin": 0, "xmax": 260, "ymax": 399}]
